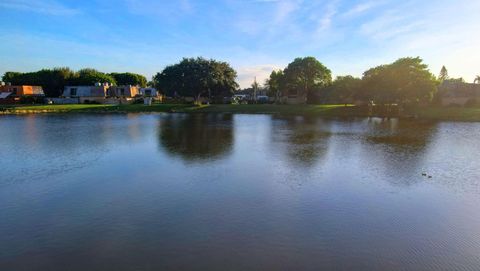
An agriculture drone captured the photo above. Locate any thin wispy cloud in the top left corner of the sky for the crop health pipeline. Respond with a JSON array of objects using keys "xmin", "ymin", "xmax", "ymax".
[{"xmin": 0, "ymin": 0, "xmax": 80, "ymax": 16}]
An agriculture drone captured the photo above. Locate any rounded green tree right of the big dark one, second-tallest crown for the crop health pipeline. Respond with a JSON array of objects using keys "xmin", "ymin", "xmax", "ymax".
[{"xmin": 283, "ymin": 57, "xmax": 332, "ymax": 101}]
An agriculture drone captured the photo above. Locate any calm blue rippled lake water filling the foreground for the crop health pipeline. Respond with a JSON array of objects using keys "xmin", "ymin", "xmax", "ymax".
[{"xmin": 0, "ymin": 114, "xmax": 480, "ymax": 271}]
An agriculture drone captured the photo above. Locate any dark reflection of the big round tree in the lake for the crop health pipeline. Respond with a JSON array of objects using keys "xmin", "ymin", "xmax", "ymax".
[{"xmin": 158, "ymin": 114, "xmax": 234, "ymax": 162}]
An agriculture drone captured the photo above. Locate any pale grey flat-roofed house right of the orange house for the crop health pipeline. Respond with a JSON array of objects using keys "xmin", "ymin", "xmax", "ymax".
[{"xmin": 62, "ymin": 83, "xmax": 110, "ymax": 103}]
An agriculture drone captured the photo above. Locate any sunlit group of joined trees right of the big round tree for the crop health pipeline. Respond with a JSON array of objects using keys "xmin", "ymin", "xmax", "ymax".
[{"xmin": 265, "ymin": 57, "xmax": 439, "ymax": 104}]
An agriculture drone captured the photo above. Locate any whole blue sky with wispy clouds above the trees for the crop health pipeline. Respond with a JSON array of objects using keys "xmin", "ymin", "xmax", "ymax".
[{"xmin": 0, "ymin": 0, "xmax": 480, "ymax": 87}]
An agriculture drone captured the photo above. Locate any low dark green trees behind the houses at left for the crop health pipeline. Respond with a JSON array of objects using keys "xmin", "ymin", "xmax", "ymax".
[{"xmin": 2, "ymin": 67, "xmax": 147, "ymax": 97}]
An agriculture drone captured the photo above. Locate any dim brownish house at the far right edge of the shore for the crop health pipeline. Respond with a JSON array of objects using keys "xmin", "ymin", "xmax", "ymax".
[{"xmin": 439, "ymin": 80, "xmax": 480, "ymax": 105}]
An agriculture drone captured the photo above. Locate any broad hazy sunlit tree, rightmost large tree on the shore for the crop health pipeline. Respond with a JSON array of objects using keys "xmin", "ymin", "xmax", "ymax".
[{"xmin": 359, "ymin": 57, "xmax": 437, "ymax": 104}]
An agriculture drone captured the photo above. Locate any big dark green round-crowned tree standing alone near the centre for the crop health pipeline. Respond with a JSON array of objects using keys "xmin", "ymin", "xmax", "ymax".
[{"xmin": 153, "ymin": 57, "xmax": 238, "ymax": 101}]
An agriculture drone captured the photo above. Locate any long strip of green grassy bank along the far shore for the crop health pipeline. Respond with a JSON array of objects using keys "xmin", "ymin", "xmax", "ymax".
[{"xmin": 0, "ymin": 104, "xmax": 480, "ymax": 122}]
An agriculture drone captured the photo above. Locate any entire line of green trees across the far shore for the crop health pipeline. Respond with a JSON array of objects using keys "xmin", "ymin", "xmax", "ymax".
[{"xmin": 3, "ymin": 57, "xmax": 466, "ymax": 105}]
